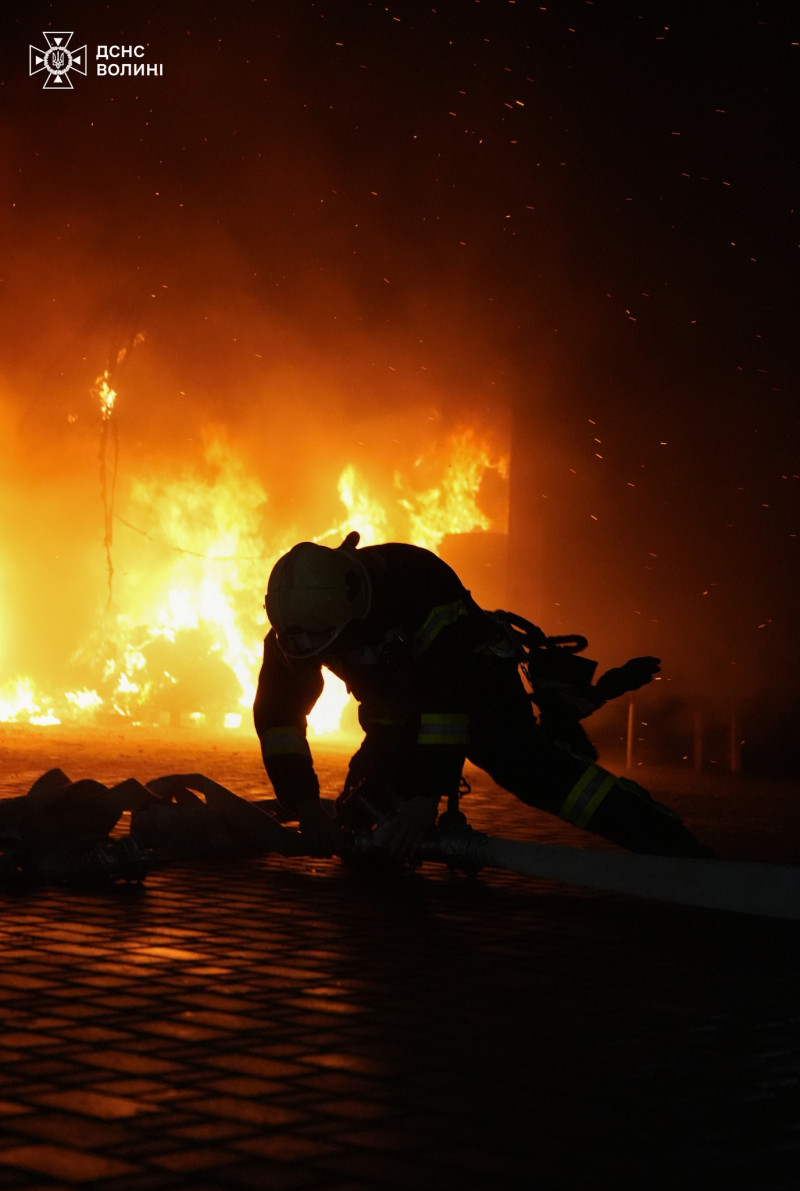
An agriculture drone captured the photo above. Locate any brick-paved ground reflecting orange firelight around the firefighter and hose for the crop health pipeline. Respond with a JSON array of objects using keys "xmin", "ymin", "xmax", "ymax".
[{"xmin": 0, "ymin": 731, "xmax": 800, "ymax": 1191}]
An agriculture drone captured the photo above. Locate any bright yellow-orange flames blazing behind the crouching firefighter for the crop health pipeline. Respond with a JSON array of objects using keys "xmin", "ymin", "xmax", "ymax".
[{"xmin": 0, "ymin": 372, "xmax": 506, "ymax": 735}]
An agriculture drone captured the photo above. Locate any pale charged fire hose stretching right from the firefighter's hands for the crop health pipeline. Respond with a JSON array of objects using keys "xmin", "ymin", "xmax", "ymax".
[{"xmin": 344, "ymin": 815, "xmax": 800, "ymax": 919}]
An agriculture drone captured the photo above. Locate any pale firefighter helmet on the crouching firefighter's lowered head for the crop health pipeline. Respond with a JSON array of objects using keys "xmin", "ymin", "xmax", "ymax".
[{"xmin": 264, "ymin": 534, "xmax": 371, "ymax": 657}]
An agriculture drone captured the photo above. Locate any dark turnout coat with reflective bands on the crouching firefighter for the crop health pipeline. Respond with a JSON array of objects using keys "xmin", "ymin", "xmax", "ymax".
[{"xmin": 254, "ymin": 543, "xmax": 493, "ymax": 811}]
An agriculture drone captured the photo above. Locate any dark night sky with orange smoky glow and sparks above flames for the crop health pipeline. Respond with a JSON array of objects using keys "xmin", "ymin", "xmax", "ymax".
[{"xmin": 0, "ymin": 0, "xmax": 800, "ymax": 762}]
